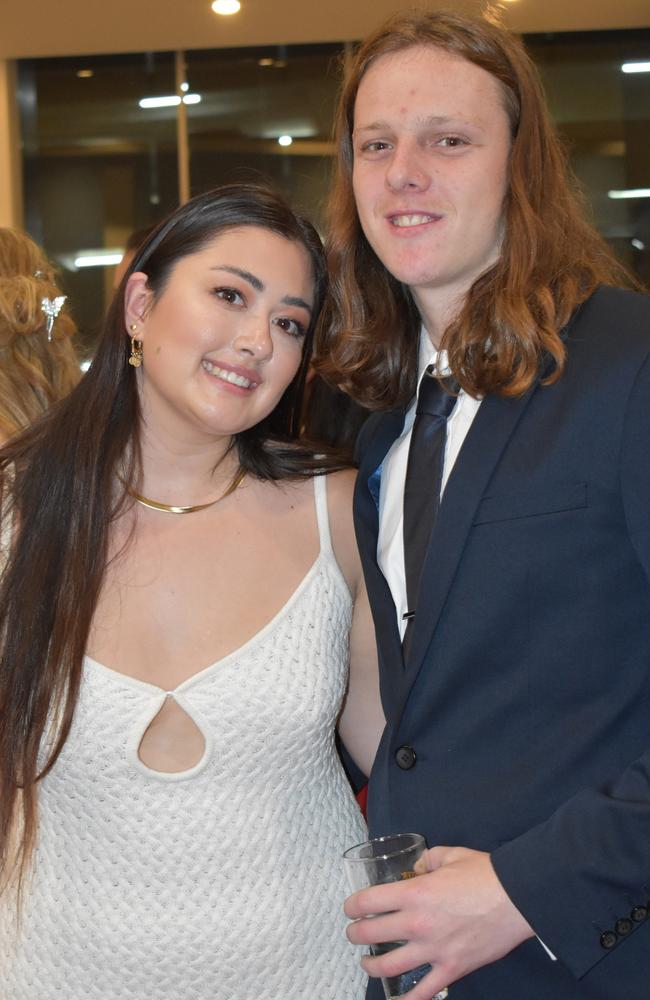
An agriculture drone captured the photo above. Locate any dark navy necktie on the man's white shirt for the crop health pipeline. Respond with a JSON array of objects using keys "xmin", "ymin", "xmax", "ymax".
[{"xmin": 402, "ymin": 365, "xmax": 457, "ymax": 660}]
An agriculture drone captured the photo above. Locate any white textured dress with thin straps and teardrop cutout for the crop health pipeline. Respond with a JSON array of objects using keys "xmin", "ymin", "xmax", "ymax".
[{"xmin": 0, "ymin": 477, "xmax": 365, "ymax": 1000}]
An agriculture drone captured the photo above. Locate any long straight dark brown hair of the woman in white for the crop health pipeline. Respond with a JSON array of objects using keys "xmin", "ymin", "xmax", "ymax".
[{"xmin": 0, "ymin": 184, "xmax": 334, "ymax": 891}]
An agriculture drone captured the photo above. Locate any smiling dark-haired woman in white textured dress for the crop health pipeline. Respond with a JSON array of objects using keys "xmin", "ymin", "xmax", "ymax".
[{"xmin": 0, "ymin": 185, "xmax": 381, "ymax": 1000}]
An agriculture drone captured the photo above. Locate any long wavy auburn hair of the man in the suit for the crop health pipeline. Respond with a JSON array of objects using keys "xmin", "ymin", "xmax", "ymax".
[{"xmin": 317, "ymin": 11, "xmax": 635, "ymax": 410}]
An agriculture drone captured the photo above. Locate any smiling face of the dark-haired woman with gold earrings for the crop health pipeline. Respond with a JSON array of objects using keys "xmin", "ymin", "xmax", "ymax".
[{"xmin": 126, "ymin": 226, "xmax": 314, "ymax": 448}]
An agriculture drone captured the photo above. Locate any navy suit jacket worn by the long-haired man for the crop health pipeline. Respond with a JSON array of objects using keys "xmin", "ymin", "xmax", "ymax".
[{"xmin": 355, "ymin": 288, "xmax": 650, "ymax": 1000}]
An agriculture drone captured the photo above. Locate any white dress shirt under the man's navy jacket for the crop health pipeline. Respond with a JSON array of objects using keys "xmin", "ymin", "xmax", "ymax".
[{"xmin": 377, "ymin": 329, "xmax": 481, "ymax": 638}]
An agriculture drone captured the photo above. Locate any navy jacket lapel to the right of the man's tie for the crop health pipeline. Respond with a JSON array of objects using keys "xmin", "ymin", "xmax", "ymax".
[{"xmin": 402, "ymin": 384, "xmax": 536, "ymax": 701}]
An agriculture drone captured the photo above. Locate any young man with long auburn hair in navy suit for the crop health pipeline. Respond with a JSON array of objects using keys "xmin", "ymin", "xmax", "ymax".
[{"xmin": 321, "ymin": 12, "xmax": 650, "ymax": 1000}]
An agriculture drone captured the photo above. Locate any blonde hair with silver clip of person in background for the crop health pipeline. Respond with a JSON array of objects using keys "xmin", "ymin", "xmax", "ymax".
[{"xmin": 0, "ymin": 229, "xmax": 80, "ymax": 444}]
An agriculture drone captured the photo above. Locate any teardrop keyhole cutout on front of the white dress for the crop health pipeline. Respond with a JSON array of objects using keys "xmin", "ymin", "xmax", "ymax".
[{"xmin": 138, "ymin": 694, "xmax": 205, "ymax": 774}]
